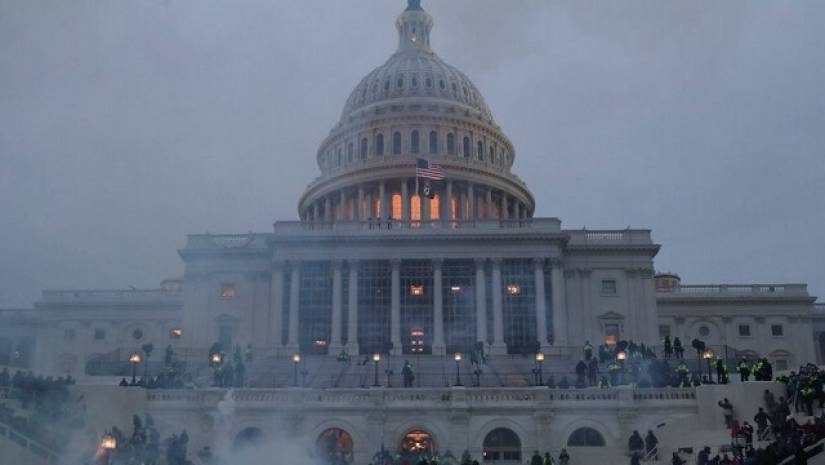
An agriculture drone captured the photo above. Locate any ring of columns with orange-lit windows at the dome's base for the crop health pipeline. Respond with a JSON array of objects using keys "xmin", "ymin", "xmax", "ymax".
[{"xmin": 301, "ymin": 178, "xmax": 532, "ymax": 222}]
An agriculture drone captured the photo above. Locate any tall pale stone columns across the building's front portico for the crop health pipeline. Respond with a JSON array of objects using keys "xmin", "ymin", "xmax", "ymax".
[{"xmin": 270, "ymin": 258, "xmax": 568, "ymax": 355}]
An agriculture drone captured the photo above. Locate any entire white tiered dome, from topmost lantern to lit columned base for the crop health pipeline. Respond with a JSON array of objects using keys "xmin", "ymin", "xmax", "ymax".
[{"xmin": 298, "ymin": 0, "xmax": 535, "ymax": 225}]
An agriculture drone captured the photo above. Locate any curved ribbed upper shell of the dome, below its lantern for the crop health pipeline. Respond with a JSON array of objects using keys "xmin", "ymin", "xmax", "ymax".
[{"xmin": 341, "ymin": 47, "xmax": 493, "ymax": 121}]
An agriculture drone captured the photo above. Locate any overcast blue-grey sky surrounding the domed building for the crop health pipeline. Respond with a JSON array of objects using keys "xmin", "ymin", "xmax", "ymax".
[{"xmin": 0, "ymin": 0, "xmax": 825, "ymax": 307}]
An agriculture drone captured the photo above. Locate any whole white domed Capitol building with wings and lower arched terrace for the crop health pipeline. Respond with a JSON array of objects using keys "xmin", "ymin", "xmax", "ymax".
[{"xmin": 0, "ymin": 1, "xmax": 825, "ymax": 464}]
